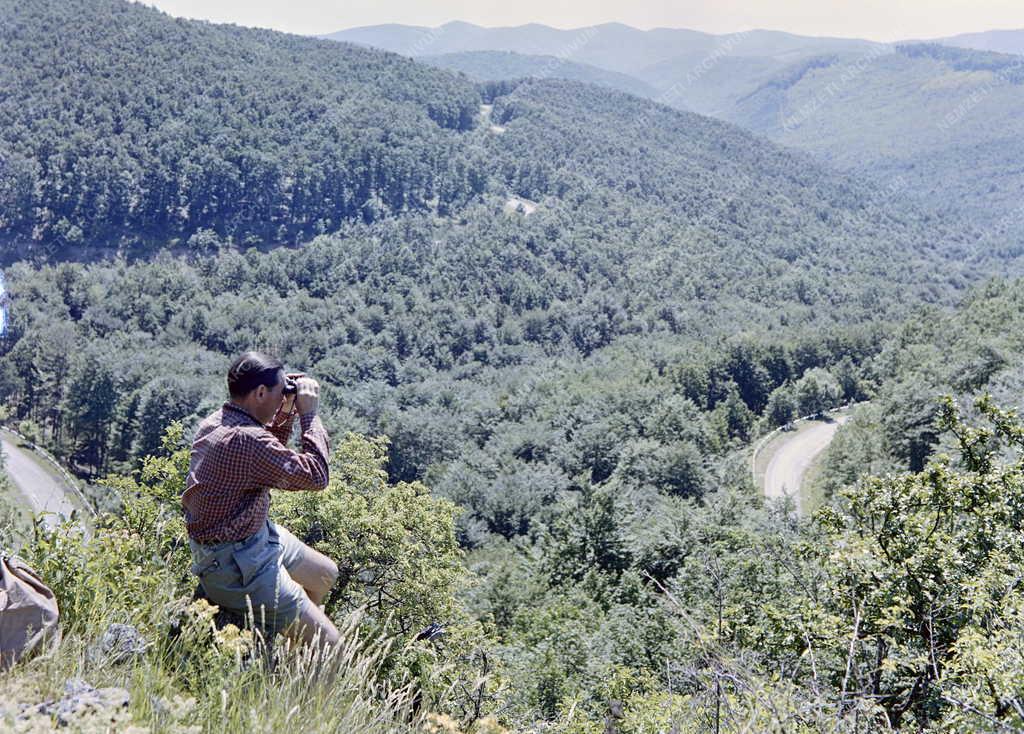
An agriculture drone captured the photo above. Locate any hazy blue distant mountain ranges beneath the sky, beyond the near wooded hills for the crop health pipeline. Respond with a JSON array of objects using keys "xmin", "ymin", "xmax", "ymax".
[{"xmin": 329, "ymin": 24, "xmax": 1024, "ymax": 244}]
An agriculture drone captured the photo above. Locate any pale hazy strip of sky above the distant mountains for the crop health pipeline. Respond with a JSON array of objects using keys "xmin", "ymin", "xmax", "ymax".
[{"xmin": 145, "ymin": 0, "xmax": 1024, "ymax": 41}]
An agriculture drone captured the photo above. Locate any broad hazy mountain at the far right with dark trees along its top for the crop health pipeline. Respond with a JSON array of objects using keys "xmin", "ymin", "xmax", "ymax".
[{"xmin": 717, "ymin": 44, "xmax": 1024, "ymax": 240}]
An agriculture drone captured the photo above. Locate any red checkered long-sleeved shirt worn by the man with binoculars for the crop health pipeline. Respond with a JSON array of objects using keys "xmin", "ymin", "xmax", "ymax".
[{"xmin": 181, "ymin": 402, "xmax": 331, "ymax": 545}]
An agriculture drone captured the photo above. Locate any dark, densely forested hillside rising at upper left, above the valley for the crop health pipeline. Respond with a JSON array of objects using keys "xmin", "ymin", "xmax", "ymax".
[{"xmin": 0, "ymin": 0, "xmax": 482, "ymax": 251}]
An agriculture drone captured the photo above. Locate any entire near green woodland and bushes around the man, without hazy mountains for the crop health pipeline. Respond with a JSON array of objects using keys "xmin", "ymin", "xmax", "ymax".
[{"xmin": 0, "ymin": 0, "xmax": 1024, "ymax": 734}]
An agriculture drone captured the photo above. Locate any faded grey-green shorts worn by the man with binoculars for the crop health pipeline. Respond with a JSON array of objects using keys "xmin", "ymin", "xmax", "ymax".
[{"xmin": 188, "ymin": 520, "xmax": 308, "ymax": 640}]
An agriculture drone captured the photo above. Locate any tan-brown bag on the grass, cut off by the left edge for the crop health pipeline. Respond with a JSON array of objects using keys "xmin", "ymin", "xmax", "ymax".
[{"xmin": 0, "ymin": 555, "xmax": 60, "ymax": 671}]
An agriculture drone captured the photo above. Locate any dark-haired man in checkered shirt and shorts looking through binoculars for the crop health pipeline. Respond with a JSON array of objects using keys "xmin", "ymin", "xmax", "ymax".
[{"xmin": 181, "ymin": 352, "xmax": 339, "ymax": 644}]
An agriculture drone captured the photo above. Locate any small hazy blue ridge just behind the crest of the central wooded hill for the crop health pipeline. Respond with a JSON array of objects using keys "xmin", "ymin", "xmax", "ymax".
[{"xmin": 419, "ymin": 51, "xmax": 657, "ymax": 97}]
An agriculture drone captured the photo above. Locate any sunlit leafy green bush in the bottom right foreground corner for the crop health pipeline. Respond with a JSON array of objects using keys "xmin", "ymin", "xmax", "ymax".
[{"xmin": 806, "ymin": 397, "xmax": 1024, "ymax": 729}]
